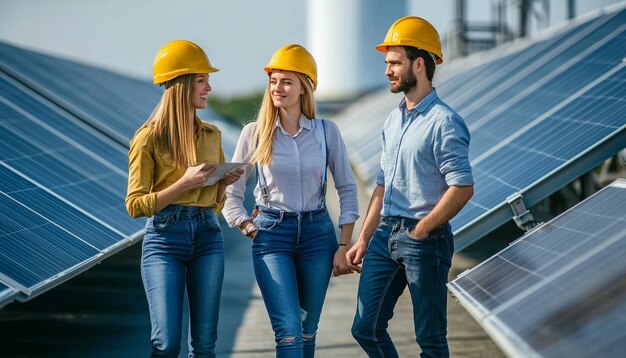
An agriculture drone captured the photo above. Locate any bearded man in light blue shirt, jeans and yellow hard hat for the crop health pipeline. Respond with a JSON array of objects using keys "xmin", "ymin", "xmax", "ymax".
[{"xmin": 346, "ymin": 16, "xmax": 474, "ymax": 357}]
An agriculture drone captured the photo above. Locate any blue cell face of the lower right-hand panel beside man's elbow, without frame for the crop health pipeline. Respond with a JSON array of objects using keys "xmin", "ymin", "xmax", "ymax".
[{"xmin": 452, "ymin": 66, "xmax": 626, "ymax": 232}]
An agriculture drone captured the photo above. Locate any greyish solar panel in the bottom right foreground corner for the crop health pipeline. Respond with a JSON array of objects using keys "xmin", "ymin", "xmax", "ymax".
[{"xmin": 448, "ymin": 179, "xmax": 626, "ymax": 357}]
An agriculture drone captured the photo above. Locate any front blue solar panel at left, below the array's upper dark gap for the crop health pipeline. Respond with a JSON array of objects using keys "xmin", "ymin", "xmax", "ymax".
[{"xmin": 0, "ymin": 69, "xmax": 143, "ymax": 300}]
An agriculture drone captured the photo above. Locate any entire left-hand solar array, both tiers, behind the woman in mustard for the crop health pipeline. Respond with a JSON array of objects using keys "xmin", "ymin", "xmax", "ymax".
[{"xmin": 0, "ymin": 43, "xmax": 239, "ymax": 306}]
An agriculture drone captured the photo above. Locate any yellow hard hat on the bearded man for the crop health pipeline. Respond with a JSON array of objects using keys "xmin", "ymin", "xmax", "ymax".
[{"xmin": 376, "ymin": 16, "xmax": 443, "ymax": 65}]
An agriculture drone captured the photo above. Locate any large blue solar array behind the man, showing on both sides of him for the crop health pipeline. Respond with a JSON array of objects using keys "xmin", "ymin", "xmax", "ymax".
[{"xmin": 339, "ymin": 5, "xmax": 626, "ymax": 250}]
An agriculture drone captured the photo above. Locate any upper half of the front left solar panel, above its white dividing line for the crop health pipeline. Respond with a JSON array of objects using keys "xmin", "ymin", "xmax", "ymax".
[{"xmin": 0, "ymin": 78, "xmax": 142, "ymax": 236}]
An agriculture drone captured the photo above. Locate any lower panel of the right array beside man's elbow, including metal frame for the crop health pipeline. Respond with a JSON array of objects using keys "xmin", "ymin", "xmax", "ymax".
[{"xmin": 452, "ymin": 59, "xmax": 626, "ymax": 249}]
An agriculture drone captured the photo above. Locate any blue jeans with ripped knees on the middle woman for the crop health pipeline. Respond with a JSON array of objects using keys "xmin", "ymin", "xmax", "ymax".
[{"xmin": 252, "ymin": 207, "xmax": 338, "ymax": 357}]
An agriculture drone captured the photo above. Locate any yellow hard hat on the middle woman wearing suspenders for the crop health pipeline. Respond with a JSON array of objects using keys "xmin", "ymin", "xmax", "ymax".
[{"xmin": 264, "ymin": 45, "xmax": 317, "ymax": 89}]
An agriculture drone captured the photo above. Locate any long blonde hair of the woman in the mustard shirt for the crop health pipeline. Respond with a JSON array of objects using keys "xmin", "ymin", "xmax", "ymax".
[{"xmin": 137, "ymin": 74, "xmax": 197, "ymax": 167}]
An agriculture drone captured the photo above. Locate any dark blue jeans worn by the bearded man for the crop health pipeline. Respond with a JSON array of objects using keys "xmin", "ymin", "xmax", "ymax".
[{"xmin": 352, "ymin": 216, "xmax": 454, "ymax": 357}]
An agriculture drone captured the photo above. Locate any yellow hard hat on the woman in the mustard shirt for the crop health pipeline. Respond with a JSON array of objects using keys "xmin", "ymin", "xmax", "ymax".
[{"xmin": 152, "ymin": 40, "xmax": 219, "ymax": 84}]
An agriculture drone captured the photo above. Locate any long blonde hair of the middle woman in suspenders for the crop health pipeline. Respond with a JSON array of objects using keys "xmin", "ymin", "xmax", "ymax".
[{"xmin": 250, "ymin": 72, "xmax": 315, "ymax": 165}]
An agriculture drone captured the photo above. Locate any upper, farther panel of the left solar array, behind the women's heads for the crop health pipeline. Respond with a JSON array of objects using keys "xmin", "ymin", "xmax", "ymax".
[{"xmin": 0, "ymin": 42, "xmax": 240, "ymax": 158}]
